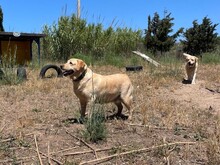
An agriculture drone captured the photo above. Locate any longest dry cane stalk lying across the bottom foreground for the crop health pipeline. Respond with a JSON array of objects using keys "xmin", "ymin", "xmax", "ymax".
[{"xmin": 80, "ymin": 142, "xmax": 196, "ymax": 165}]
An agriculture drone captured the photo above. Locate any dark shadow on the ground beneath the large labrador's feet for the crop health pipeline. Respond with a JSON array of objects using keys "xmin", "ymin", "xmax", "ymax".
[{"xmin": 62, "ymin": 114, "xmax": 128, "ymax": 124}]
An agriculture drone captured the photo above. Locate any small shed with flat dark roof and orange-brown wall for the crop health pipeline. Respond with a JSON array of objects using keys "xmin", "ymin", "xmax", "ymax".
[{"xmin": 0, "ymin": 32, "xmax": 45, "ymax": 65}]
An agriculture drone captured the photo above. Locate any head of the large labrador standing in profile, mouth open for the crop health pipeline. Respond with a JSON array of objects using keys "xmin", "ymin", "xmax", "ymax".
[{"xmin": 60, "ymin": 58, "xmax": 87, "ymax": 80}]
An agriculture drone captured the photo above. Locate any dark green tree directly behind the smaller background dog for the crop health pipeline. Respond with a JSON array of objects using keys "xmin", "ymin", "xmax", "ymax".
[{"xmin": 181, "ymin": 17, "xmax": 218, "ymax": 55}]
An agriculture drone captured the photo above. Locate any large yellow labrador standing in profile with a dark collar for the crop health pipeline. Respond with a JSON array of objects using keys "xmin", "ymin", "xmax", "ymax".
[{"xmin": 60, "ymin": 58, "xmax": 133, "ymax": 119}]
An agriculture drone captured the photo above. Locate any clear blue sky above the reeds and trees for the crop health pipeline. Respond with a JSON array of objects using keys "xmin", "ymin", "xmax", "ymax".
[{"xmin": 0, "ymin": 0, "xmax": 220, "ymax": 35}]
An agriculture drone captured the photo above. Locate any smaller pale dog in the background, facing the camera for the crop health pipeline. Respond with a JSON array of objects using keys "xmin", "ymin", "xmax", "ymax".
[{"xmin": 183, "ymin": 53, "xmax": 198, "ymax": 84}]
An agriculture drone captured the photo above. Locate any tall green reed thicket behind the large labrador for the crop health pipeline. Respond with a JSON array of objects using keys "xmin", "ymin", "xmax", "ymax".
[{"xmin": 43, "ymin": 14, "xmax": 142, "ymax": 60}]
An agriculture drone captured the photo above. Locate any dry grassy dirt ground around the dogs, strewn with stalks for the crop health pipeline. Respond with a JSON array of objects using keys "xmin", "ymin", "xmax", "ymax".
[{"xmin": 0, "ymin": 63, "xmax": 220, "ymax": 165}]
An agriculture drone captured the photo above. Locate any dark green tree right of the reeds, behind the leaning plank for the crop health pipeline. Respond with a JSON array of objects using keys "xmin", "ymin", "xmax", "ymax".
[{"xmin": 145, "ymin": 13, "xmax": 183, "ymax": 55}]
